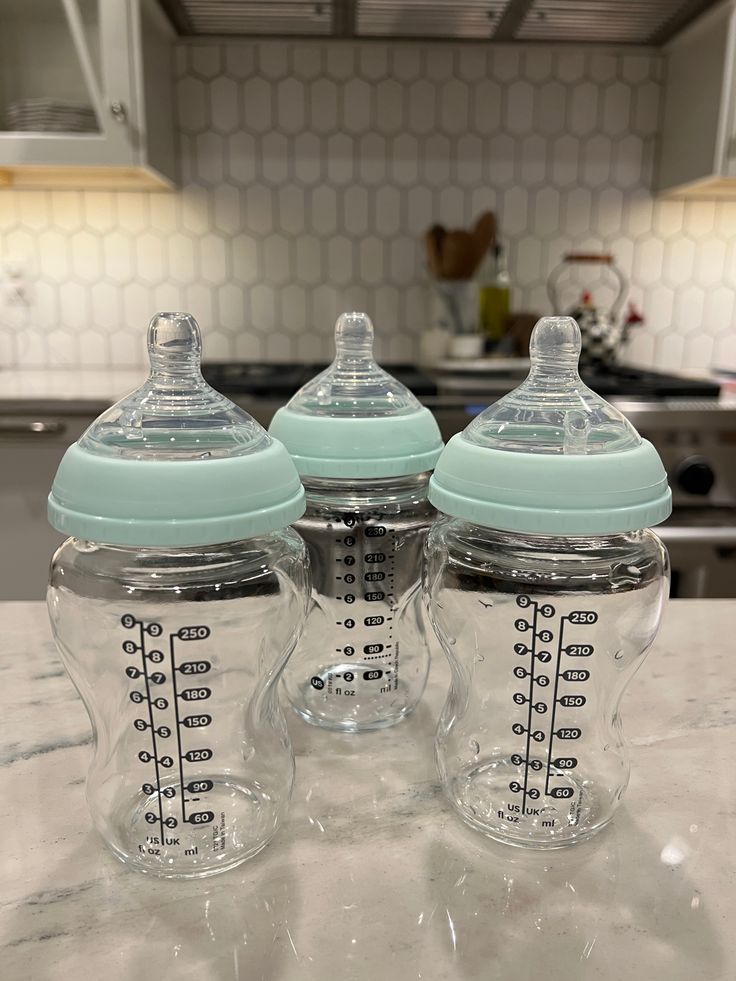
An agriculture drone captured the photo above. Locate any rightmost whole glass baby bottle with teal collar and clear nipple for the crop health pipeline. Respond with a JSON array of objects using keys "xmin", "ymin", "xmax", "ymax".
[{"xmin": 425, "ymin": 317, "xmax": 671, "ymax": 847}]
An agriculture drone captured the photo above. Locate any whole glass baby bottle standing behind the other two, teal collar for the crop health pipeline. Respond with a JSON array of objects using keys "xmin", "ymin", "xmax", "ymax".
[{"xmin": 270, "ymin": 313, "xmax": 442, "ymax": 731}]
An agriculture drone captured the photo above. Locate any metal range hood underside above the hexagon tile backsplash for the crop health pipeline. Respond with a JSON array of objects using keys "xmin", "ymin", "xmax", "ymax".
[{"xmin": 159, "ymin": 0, "xmax": 714, "ymax": 46}]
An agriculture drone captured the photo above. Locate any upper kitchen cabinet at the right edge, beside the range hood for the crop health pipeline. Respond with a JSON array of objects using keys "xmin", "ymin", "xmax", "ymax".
[{"xmin": 655, "ymin": 0, "xmax": 736, "ymax": 198}]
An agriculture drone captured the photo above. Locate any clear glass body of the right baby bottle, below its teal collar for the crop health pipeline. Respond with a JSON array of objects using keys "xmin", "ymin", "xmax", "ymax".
[{"xmin": 425, "ymin": 518, "xmax": 669, "ymax": 847}]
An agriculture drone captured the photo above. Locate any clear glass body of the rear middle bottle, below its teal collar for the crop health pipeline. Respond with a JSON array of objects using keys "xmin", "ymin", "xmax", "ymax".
[{"xmin": 284, "ymin": 473, "xmax": 435, "ymax": 731}]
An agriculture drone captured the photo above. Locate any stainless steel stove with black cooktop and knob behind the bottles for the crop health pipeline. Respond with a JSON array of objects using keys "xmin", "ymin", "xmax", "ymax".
[{"xmin": 204, "ymin": 361, "xmax": 736, "ymax": 597}]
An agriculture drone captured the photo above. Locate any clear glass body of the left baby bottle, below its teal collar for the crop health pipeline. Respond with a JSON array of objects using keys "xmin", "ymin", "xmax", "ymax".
[{"xmin": 48, "ymin": 529, "xmax": 308, "ymax": 877}]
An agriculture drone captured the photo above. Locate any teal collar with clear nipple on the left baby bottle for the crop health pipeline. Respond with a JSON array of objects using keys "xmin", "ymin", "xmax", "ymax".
[{"xmin": 48, "ymin": 313, "xmax": 305, "ymax": 547}]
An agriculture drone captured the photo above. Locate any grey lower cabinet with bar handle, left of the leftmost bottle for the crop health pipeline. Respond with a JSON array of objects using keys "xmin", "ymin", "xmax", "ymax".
[{"xmin": 0, "ymin": 413, "xmax": 92, "ymax": 600}]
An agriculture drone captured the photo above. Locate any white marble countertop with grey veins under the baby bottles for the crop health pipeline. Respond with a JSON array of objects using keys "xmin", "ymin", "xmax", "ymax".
[{"xmin": 0, "ymin": 600, "xmax": 736, "ymax": 981}]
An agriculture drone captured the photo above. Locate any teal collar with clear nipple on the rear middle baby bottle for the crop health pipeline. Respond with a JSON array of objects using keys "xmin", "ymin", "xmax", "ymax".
[{"xmin": 269, "ymin": 313, "xmax": 443, "ymax": 478}]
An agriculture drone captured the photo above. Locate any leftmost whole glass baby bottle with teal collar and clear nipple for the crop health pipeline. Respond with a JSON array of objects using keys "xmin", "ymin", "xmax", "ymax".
[{"xmin": 48, "ymin": 313, "xmax": 309, "ymax": 877}]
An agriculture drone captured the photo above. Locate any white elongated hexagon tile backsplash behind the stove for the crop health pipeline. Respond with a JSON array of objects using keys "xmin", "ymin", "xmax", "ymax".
[{"xmin": 0, "ymin": 41, "xmax": 736, "ymax": 369}]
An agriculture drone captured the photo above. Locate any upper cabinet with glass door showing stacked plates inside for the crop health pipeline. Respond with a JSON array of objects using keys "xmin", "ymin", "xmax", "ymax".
[{"xmin": 0, "ymin": 0, "xmax": 176, "ymax": 189}]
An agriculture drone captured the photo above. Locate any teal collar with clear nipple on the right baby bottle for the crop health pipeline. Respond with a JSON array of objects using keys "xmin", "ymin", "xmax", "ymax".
[{"xmin": 429, "ymin": 317, "xmax": 672, "ymax": 535}]
